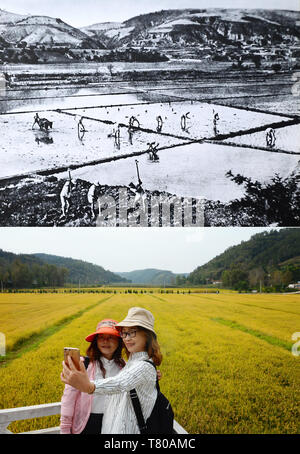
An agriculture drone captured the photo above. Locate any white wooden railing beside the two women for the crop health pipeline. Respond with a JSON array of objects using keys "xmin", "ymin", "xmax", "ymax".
[{"xmin": 0, "ymin": 402, "xmax": 188, "ymax": 434}]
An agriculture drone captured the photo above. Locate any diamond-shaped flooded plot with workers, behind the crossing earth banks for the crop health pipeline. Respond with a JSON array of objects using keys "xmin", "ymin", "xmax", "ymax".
[{"xmin": 62, "ymin": 101, "xmax": 289, "ymax": 140}]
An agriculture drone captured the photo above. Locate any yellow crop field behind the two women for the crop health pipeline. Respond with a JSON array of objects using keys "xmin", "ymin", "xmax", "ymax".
[{"xmin": 0, "ymin": 293, "xmax": 300, "ymax": 433}]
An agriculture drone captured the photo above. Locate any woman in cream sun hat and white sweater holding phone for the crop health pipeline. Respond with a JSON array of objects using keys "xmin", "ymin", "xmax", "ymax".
[{"xmin": 61, "ymin": 307, "xmax": 162, "ymax": 434}]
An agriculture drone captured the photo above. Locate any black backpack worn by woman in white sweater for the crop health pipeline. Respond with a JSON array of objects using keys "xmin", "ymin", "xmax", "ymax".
[{"xmin": 130, "ymin": 360, "xmax": 174, "ymax": 434}]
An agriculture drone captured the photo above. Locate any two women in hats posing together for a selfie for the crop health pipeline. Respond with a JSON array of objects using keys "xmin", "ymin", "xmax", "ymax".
[{"xmin": 61, "ymin": 307, "xmax": 162, "ymax": 434}]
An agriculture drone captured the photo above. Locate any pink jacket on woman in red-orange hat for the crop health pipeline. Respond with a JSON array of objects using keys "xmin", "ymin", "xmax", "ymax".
[{"xmin": 60, "ymin": 361, "xmax": 95, "ymax": 434}]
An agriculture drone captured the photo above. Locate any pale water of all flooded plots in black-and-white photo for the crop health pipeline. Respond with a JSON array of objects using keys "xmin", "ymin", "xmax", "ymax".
[{"xmin": 0, "ymin": 85, "xmax": 299, "ymax": 202}]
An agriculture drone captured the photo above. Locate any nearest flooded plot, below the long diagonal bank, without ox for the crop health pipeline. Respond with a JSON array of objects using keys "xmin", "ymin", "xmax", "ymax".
[{"xmin": 56, "ymin": 144, "xmax": 298, "ymax": 202}]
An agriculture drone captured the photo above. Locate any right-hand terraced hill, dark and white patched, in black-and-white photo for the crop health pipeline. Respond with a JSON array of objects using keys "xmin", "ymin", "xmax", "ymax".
[{"xmin": 82, "ymin": 8, "xmax": 300, "ymax": 48}]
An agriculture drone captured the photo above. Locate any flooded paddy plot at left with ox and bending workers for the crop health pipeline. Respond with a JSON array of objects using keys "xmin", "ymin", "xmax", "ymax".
[{"xmin": 0, "ymin": 111, "xmax": 189, "ymax": 178}]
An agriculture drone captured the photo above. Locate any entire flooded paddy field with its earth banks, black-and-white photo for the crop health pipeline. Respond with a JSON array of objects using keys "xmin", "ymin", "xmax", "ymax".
[{"xmin": 0, "ymin": 66, "xmax": 300, "ymax": 226}]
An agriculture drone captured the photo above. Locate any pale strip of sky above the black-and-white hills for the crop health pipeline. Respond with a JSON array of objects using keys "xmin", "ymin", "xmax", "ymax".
[{"xmin": 0, "ymin": 0, "xmax": 299, "ymax": 27}]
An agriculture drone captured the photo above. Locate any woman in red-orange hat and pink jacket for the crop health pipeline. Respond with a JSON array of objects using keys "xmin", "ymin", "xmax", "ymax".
[{"xmin": 60, "ymin": 319, "xmax": 125, "ymax": 434}]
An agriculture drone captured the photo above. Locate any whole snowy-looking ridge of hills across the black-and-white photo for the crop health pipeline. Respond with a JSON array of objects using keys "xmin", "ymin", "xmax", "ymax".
[{"xmin": 0, "ymin": 8, "xmax": 300, "ymax": 49}]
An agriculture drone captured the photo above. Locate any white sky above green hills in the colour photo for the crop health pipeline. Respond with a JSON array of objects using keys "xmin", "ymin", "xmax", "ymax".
[{"xmin": 0, "ymin": 227, "xmax": 282, "ymax": 273}]
